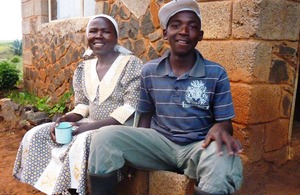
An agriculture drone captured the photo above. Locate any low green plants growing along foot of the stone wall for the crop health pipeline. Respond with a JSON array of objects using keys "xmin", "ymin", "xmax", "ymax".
[{"xmin": 8, "ymin": 92, "xmax": 73, "ymax": 117}]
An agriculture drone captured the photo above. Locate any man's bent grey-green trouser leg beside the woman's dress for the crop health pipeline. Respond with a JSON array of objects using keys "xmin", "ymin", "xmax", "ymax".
[{"xmin": 88, "ymin": 126, "xmax": 177, "ymax": 194}]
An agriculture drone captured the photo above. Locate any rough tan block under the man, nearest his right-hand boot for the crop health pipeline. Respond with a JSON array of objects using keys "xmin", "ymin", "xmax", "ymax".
[{"xmin": 149, "ymin": 171, "xmax": 194, "ymax": 195}]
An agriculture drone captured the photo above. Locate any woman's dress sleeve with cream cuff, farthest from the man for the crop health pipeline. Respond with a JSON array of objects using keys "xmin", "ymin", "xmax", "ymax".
[{"xmin": 69, "ymin": 63, "xmax": 89, "ymax": 117}]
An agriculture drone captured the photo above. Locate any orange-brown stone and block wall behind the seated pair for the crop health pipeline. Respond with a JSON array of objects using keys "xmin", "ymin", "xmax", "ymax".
[{"xmin": 22, "ymin": 0, "xmax": 300, "ymax": 167}]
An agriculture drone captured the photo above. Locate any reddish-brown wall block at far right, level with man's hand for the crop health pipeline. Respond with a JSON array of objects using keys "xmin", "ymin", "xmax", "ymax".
[{"xmin": 264, "ymin": 119, "xmax": 290, "ymax": 152}]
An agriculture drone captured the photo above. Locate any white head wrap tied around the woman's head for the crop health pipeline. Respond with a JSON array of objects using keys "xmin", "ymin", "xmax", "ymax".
[{"xmin": 83, "ymin": 14, "xmax": 132, "ymax": 57}]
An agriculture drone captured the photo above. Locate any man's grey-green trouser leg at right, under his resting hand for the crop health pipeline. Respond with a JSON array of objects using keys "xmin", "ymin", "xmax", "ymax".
[{"xmin": 178, "ymin": 142, "xmax": 243, "ymax": 194}]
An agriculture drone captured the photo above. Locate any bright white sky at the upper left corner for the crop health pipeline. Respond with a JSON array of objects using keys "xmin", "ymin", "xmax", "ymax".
[{"xmin": 0, "ymin": 0, "xmax": 22, "ymax": 41}]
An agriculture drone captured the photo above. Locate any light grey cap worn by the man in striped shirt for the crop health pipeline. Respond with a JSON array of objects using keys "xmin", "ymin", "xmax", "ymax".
[{"xmin": 158, "ymin": 0, "xmax": 201, "ymax": 29}]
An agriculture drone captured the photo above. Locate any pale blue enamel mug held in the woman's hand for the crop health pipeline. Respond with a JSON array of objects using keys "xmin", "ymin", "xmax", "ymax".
[{"xmin": 55, "ymin": 122, "xmax": 73, "ymax": 144}]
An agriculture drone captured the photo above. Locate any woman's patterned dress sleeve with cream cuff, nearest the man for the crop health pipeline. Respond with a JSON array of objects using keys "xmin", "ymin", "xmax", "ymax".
[{"xmin": 110, "ymin": 56, "xmax": 143, "ymax": 124}]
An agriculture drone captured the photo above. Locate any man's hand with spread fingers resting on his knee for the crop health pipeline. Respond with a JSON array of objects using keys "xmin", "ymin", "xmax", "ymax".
[{"xmin": 202, "ymin": 120, "xmax": 242, "ymax": 155}]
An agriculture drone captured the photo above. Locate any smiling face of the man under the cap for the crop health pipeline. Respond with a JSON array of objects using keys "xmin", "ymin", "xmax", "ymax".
[{"xmin": 163, "ymin": 11, "xmax": 203, "ymax": 56}]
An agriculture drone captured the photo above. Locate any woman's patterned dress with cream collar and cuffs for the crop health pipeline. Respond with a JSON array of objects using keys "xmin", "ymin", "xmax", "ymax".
[{"xmin": 13, "ymin": 54, "xmax": 142, "ymax": 194}]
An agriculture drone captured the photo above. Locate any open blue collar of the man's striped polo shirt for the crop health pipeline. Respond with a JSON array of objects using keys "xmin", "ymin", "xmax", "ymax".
[{"xmin": 156, "ymin": 49, "xmax": 205, "ymax": 77}]
